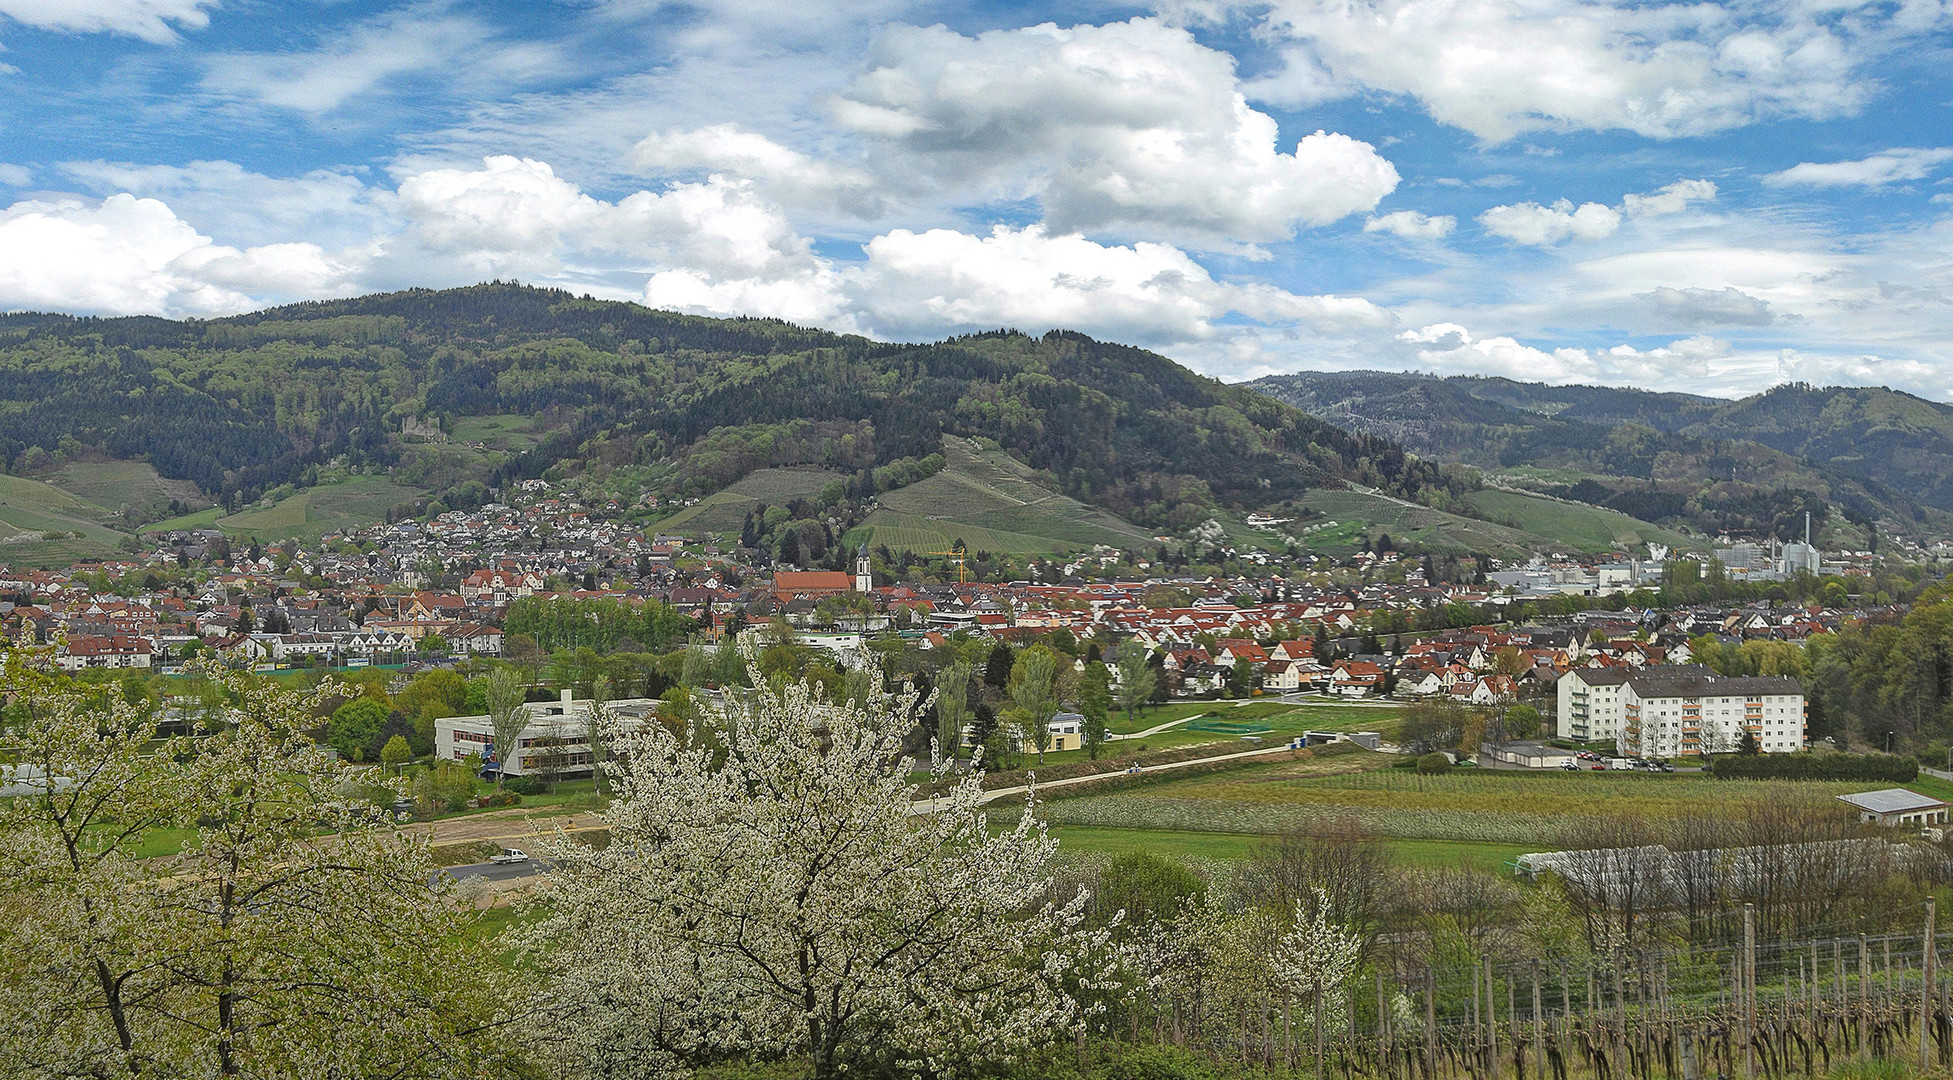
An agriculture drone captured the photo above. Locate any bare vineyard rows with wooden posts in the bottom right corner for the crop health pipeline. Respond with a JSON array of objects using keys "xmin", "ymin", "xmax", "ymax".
[{"xmin": 1100, "ymin": 900, "xmax": 1953, "ymax": 1080}]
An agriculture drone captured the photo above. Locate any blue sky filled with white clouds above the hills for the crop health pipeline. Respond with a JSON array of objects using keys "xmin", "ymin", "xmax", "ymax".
[{"xmin": 0, "ymin": 0, "xmax": 1953, "ymax": 400}]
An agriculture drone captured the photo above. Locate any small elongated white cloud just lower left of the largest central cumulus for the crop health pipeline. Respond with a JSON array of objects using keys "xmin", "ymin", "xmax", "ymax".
[{"xmin": 631, "ymin": 123, "xmax": 887, "ymax": 217}]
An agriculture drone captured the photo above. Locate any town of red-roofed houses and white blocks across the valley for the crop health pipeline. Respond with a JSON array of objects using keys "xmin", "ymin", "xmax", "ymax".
[{"xmin": 0, "ymin": 468, "xmax": 1902, "ymax": 766}]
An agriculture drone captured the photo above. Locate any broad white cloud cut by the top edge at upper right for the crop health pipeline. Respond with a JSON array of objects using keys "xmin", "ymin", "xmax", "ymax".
[{"xmin": 1250, "ymin": 0, "xmax": 1913, "ymax": 143}]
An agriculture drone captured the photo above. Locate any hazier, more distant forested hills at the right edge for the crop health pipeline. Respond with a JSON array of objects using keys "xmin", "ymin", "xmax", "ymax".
[{"xmin": 1248, "ymin": 371, "xmax": 1953, "ymax": 541}]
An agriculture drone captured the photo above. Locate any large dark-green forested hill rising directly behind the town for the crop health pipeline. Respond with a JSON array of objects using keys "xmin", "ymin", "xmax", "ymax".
[{"xmin": 0, "ymin": 283, "xmax": 1443, "ymax": 525}]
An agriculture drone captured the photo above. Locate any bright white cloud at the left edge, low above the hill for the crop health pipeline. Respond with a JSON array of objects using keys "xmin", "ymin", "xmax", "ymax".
[{"xmin": 0, "ymin": 195, "xmax": 348, "ymax": 316}]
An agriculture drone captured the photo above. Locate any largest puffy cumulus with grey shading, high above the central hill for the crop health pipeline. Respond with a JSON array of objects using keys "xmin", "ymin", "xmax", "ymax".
[{"xmin": 832, "ymin": 20, "xmax": 1398, "ymax": 242}]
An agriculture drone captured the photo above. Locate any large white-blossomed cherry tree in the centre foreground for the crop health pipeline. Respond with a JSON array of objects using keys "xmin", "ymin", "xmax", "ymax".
[{"xmin": 529, "ymin": 664, "xmax": 1103, "ymax": 1080}]
